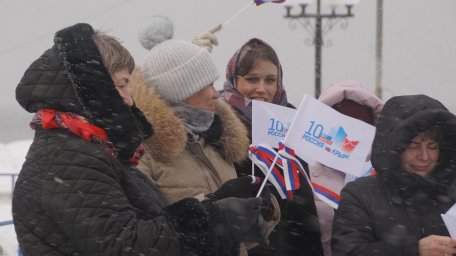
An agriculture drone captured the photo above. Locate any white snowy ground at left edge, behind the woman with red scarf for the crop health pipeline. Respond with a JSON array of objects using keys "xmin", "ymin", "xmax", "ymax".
[{"xmin": 0, "ymin": 140, "xmax": 32, "ymax": 256}]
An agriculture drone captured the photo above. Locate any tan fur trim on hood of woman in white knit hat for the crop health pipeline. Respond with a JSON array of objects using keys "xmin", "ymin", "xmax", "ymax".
[{"xmin": 130, "ymin": 68, "xmax": 249, "ymax": 163}]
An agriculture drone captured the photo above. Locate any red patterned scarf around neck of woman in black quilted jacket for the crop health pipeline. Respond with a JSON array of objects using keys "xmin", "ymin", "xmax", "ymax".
[{"xmin": 30, "ymin": 109, "xmax": 144, "ymax": 165}]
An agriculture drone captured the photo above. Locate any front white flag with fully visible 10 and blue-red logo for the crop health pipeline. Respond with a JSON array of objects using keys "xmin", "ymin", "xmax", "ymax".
[{"xmin": 283, "ymin": 95, "xmax": 375, "ymax": 176}]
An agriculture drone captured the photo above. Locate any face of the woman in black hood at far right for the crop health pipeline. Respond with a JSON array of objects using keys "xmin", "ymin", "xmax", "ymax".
[{"xmin": 401, "ymin": 132, "xmax": 440, "ymax": 177}]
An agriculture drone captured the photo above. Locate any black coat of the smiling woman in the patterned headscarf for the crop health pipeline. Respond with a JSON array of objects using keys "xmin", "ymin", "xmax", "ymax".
[{"xmin": 236, "ymin": 104, "xmax": 323, "ymax": 256}]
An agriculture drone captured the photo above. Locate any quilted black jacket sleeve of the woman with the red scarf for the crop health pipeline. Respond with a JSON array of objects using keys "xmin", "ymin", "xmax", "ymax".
[{"xmin": 40, "ymin": 150, "xmax": 228, "ymax": 256}]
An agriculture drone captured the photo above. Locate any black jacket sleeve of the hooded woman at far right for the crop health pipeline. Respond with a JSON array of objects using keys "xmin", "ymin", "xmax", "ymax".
[{"xmin": 331, "ymin": 181, "xmax": 418, "ymax": 256}]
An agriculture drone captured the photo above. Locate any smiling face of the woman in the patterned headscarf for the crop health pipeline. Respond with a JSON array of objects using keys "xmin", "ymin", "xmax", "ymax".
[{"xmin": 236, "ymin": 60, "xmax": 279, "ymax": 103}]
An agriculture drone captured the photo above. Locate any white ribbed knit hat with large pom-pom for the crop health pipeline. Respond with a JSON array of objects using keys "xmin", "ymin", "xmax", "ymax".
[{"xmin": 139, "ymin": 16, "xmax": 220, "ymax": 102}]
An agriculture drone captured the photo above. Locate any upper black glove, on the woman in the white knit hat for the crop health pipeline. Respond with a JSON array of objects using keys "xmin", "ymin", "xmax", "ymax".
[{"xmin": 207, "ymin": 175, "xmax": 261, "ymax": 200}]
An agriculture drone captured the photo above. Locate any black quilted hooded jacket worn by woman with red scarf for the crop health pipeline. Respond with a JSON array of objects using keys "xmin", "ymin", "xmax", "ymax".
[{"xmin": 12, "ymin": 24, "xmax": 229, "ymax": 256}]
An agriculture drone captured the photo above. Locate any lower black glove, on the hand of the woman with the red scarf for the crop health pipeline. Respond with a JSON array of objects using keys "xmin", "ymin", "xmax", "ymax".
[{"xmin": 206, "ymin": 197, "xmax": 267, "ymax": 242}]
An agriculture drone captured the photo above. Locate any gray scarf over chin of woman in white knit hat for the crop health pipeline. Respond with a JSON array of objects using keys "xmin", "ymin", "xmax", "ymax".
[{"xmin": 171, "ymin": 102, "xmax": 214, "ymax": 139}]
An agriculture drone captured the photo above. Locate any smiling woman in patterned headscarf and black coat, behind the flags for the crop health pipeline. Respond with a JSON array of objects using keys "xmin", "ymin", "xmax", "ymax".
[{"xmin": 221, "ymin": 38, "xmax": 323, "ymax": 255}]
